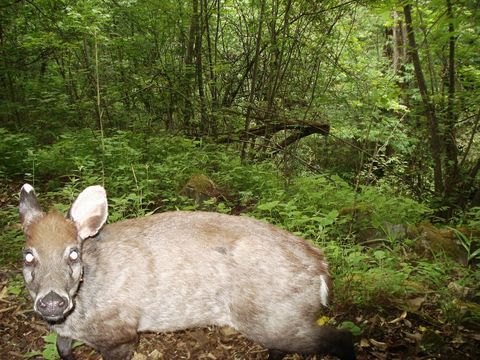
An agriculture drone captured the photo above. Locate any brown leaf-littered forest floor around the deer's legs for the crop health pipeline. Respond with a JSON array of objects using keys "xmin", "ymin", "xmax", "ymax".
[{"xmin": 0, "ymin": 266, "xmax": 480, "ymax": 360}]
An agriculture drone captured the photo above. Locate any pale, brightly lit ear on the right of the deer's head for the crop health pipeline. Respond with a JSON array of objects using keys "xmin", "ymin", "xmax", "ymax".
[{"xmin": 68, "ymin": 185, "xmax": 108, "ymax": 240}]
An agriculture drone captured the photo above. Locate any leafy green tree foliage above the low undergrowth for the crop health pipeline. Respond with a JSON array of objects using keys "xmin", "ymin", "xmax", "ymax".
[{"xmin": 0, "ymin": 0, "xmax": 480, "ymax": 214}]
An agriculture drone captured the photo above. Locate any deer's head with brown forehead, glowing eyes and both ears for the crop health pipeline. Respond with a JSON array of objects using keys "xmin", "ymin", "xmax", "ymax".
[{"xmin": 20, "ymin": 184, "xmax": 107, "ymax": 322}]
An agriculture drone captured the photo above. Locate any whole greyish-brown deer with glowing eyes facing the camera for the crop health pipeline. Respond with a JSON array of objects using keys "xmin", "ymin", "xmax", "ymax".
[{"xmin": 19, "ymin": 184, "xmax": 355, "ymax": 360}]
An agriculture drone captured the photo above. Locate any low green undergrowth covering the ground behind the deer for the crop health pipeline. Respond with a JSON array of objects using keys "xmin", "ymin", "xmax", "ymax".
[{"xmin": 0, "ymin": 129, "xmax": 480, "ymax": 334}]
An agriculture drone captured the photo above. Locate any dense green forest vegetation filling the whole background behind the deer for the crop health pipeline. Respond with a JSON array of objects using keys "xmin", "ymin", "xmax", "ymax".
[{"xmin": 0, "ymin": 0, "xmax": 480, "ymax": 356}]
